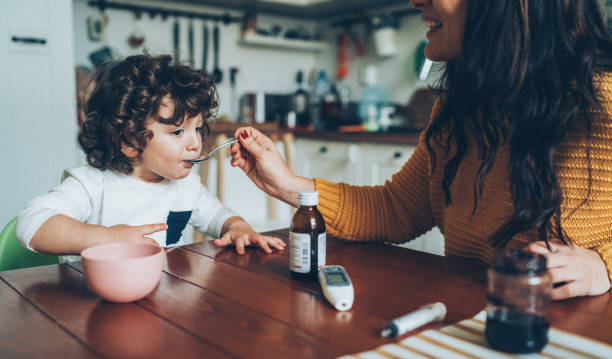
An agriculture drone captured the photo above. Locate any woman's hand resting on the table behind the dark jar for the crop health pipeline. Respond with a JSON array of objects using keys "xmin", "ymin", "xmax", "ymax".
[{"xmin": 527, "ymin": 241, "xmax": 610, "ymax": 300}]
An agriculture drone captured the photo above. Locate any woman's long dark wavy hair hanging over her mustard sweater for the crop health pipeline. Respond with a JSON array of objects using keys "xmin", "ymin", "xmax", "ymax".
[{"xmin": 425, "ymin": 0, "xmax": 612, "ymax": 246}]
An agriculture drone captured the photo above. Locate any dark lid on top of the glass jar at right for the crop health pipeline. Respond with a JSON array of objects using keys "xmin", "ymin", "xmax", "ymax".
[{"xmin": 493, "ymin": 249, "xmax": 546, "ymax": 275}]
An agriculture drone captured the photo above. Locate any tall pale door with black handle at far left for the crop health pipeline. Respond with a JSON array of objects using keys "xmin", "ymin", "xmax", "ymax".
[{"xmin": 0, "ymin": 0, "xmax": 77, "ymax": 227}]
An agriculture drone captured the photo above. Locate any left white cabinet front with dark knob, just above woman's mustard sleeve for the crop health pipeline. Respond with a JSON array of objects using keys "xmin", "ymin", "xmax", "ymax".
[{"xmin": 295, "ymin": 139, "xmax": 363, "ymax": 185}]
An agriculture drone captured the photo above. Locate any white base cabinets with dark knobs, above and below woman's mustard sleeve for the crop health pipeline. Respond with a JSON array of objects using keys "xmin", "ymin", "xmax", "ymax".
[{"xmin": 295, "ymin": 138, "xmax": 444, "ymax": 255}]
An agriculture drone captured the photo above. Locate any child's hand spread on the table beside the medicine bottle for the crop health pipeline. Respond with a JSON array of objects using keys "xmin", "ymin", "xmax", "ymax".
[{"xmin": 214, "ymin": 220, "xmax": 285, "ymax": 255}]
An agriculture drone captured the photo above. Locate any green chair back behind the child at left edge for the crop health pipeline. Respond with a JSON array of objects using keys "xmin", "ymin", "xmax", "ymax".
[{"xmin": 0, "ymin": 218, "xmax": 59, "ymax": 272}]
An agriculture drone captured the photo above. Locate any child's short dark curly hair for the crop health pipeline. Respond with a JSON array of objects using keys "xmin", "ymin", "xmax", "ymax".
[{"xmin": 78, "ymin": 53, "xmax": 218, "ymax": 174}]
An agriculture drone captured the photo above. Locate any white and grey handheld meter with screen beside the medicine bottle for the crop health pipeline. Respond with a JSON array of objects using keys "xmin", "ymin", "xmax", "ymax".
[{"xmin": 319, "ymin": 265, "xmax": 355, "ymax": 311}]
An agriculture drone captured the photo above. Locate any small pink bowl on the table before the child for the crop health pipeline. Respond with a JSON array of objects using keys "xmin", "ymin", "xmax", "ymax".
[{"xmin": 81, "ymin": 242, "xmax": 165, "ymax": 303}]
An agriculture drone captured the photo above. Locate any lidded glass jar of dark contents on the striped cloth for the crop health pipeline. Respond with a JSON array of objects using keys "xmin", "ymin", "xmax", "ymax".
[{"xmin": 485, "ymin": 249, "xmax": 552, "ymax": 353}]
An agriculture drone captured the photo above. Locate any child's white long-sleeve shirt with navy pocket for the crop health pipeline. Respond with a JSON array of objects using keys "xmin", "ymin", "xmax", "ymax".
[{"xmin": 15, "ymin": 166, "xmax": 236, "ymax": 250}]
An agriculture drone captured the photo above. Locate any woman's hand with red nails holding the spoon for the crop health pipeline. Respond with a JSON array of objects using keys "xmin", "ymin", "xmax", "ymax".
[{"xmin": 230, "ymin": 127, "xmax": 314, "ymax": 207}]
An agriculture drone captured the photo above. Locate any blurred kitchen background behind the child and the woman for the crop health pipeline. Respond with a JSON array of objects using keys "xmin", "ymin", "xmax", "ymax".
[{"xmin": 0, "ymin": 0, "xmax": 612, "ymax": 254}]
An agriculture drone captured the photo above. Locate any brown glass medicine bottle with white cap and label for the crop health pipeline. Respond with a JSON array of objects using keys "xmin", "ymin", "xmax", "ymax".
[{"xmin": 289, "ymin": 191, "xmax": 326, "ymax": 280}]
